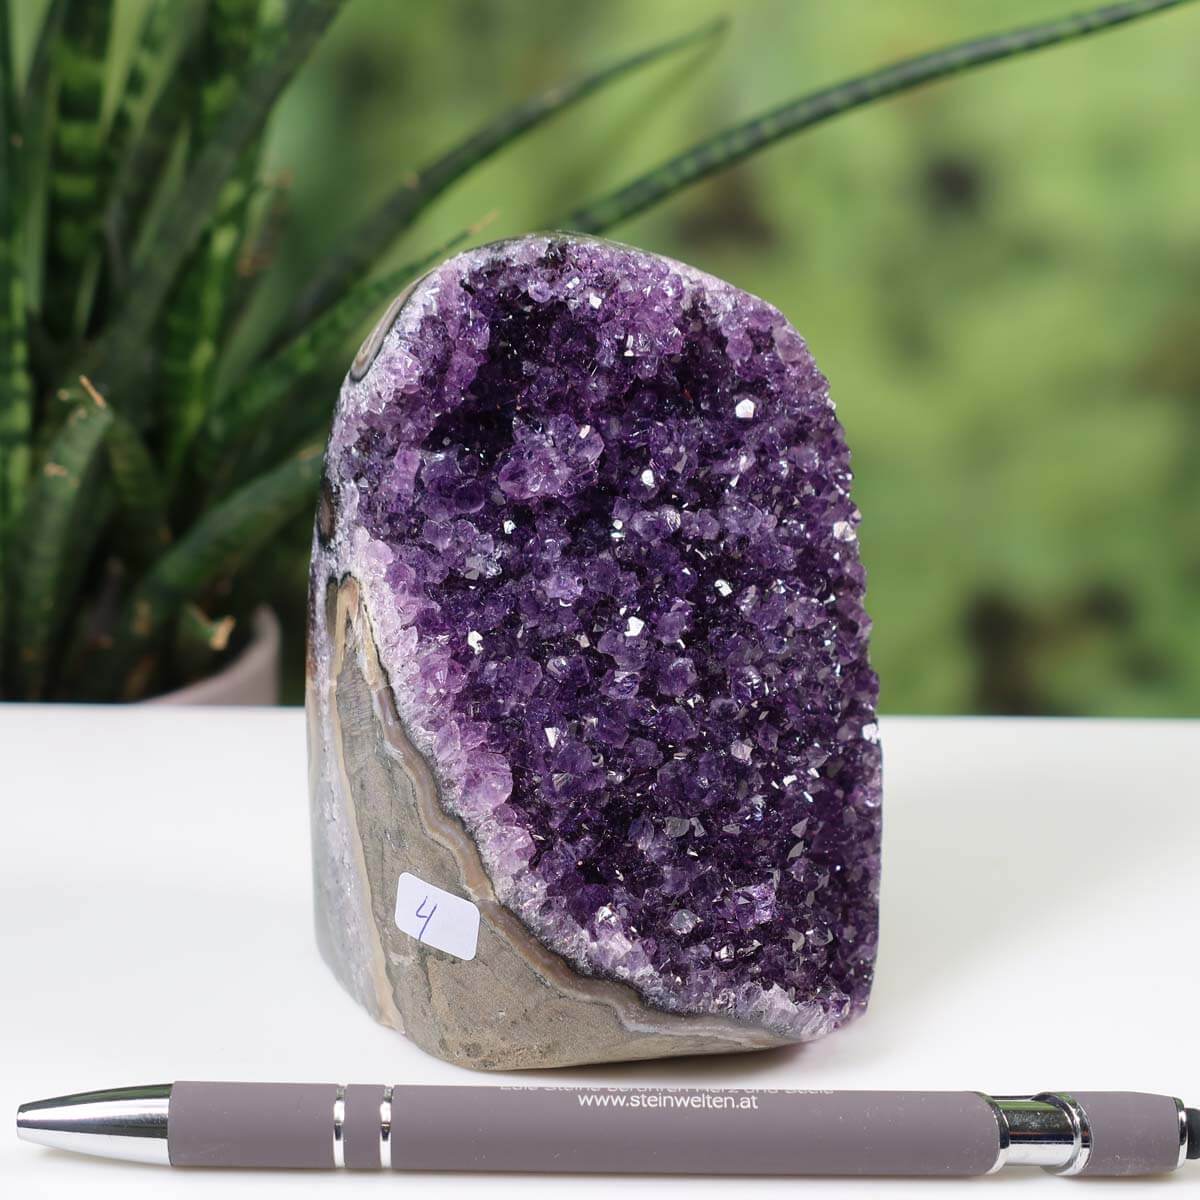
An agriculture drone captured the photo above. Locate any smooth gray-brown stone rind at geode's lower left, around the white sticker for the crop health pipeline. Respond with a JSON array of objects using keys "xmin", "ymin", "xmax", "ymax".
[{"xmin": 308, "ymin": 578, "xmax": 784, "ymax": 1070}]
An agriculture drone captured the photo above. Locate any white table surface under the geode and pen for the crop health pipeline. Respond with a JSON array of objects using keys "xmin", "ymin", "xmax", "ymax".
[{"xmin": 0, "ymin": 706, "xmax": 1200, "ymax": 1200}]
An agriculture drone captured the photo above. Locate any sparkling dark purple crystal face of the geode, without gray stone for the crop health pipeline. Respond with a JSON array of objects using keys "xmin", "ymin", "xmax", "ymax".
[{"xmin": 329, "ymin": 236, "xmax": 880, "ymax": 1038}]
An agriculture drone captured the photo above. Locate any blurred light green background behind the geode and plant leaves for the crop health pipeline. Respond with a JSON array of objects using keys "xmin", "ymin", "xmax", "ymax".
[{"xmin": 37, "ymin": 0, "xmax": 1200, "ymax": 715}]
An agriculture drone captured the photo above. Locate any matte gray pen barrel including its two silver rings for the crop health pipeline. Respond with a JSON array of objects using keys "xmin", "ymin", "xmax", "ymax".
[{"xmin": 168, "ymin": 1082, "xmax": 1000, "ymax": 1176}]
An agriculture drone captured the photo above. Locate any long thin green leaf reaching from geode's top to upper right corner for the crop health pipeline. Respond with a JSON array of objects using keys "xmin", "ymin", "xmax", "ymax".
[{"xmin": 562, "ymin": 0, "xmax": 1190, "ymax": 233}]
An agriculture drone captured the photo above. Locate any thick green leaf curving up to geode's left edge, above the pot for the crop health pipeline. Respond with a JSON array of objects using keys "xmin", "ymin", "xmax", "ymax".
[{"xmin": 106, "ymin": 443, "xmax": 324, "ymax": 700}]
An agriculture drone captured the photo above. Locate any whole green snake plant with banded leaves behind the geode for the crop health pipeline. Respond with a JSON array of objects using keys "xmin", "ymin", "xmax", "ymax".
[{"xmin": 0, "ymin": 0, "xmax": 1187, "ymax": 701}]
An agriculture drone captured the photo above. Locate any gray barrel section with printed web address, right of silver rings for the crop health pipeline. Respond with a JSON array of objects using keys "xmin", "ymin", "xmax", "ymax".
[{"xmin": 391, "ymin": 1087, "xmax": 1000, "ymax": 1175}]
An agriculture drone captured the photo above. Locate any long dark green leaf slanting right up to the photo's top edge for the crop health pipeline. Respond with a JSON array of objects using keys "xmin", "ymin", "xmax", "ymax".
[{"xmin": 80, "ymin": 0, "xmax": 344, "ymax": 408}]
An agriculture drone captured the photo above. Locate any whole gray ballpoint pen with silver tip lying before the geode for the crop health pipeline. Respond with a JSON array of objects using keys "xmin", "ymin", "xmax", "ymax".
[{"xmin": 17, "ymin": 1082, "xmax": 1200, "ymax": 1176}]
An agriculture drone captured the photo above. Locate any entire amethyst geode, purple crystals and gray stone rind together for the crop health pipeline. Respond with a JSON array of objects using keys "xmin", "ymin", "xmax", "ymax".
[{"xmin": 308, "ymin": 235, "xmax": 880, "ymax": 1068}]
